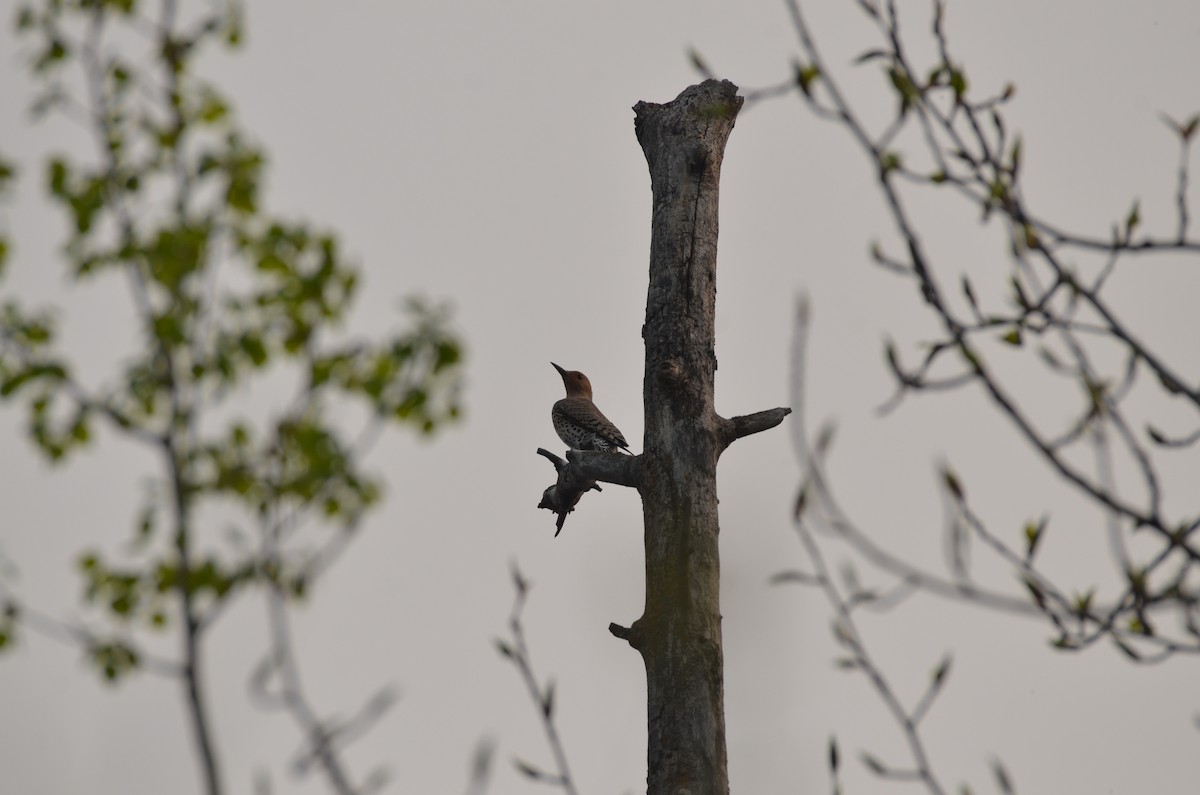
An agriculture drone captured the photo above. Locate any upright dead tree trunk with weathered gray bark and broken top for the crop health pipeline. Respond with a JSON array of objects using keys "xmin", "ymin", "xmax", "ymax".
[{"xmin": 628, "ymin": 80, "xmax": 739, "ymax": 795}]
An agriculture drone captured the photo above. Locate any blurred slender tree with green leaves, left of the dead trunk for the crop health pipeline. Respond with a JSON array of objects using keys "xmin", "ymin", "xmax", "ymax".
[{"xmin": 0, "ymin": 0, "xmax": 462, "ymax": 795}]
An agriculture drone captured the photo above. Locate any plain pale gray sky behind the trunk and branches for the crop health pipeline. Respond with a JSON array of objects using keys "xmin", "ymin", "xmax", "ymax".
[{"xmin": 0, "ymin": 0, "xmax": 1200, "ymax": 795}]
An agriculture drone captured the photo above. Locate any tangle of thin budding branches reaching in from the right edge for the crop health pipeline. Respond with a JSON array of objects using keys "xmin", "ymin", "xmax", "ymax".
[{"xmin": 787, "ymin": 0, "xmax": 1200, "ymax": 662}]
